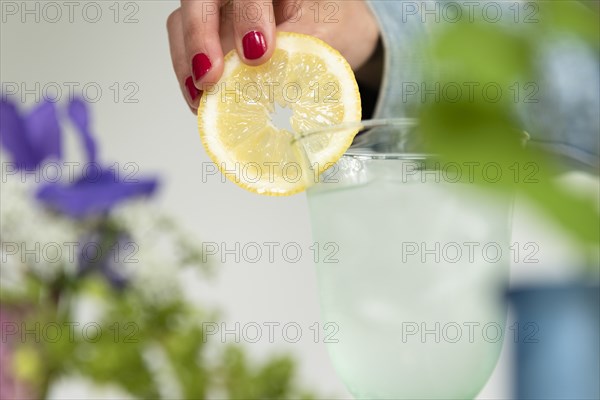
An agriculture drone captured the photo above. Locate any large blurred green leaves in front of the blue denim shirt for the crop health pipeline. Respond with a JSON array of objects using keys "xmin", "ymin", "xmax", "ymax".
[{"xmin": 419, "ymin": 1, "xmax": 600, "ymax": 267}]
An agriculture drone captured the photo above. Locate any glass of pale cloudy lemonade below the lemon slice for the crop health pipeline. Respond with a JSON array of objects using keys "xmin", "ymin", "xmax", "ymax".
[{"xmin": 308, "ymin": 119, "xmax": 511, "ymax": 399}]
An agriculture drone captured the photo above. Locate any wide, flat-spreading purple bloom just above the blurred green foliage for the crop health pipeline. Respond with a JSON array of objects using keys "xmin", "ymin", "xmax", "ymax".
[{"xmin": 36, "ymin": 169, "xmax": 158, "ymax": 218}]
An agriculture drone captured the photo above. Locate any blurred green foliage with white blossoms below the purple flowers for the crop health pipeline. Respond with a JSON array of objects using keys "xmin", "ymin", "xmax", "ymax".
[{"xmin": 1, "ymin": 211, "xmax": 311, "ymax": 399}]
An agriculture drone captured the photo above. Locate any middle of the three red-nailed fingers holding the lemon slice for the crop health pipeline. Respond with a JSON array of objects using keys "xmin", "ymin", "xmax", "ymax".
[{"xmin": 181, "ymin": 0, "xmax": 223, "ymax": 89}]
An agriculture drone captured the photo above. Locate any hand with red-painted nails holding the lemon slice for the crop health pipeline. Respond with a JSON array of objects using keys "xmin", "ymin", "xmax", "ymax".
[{"xmin": 167, "ymin": 0, "xmax": 379, "ymax": 112}]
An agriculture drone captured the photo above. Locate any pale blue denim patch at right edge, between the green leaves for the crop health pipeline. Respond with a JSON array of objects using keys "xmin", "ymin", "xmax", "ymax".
[{"xmin": 519, "ymin": 38, "xmax": 600, "ymax": 172}]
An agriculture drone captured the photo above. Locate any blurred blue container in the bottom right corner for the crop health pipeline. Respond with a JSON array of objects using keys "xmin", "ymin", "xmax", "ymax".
[{"xmin": 509, "ymin": 284, "xmax": 600, "ymax": 399}]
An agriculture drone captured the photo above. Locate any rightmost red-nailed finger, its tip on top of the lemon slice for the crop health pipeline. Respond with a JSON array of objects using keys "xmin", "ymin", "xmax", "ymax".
[{"xmin": 233, "ymin": 0, "xmax": 275, "ymax": 65}]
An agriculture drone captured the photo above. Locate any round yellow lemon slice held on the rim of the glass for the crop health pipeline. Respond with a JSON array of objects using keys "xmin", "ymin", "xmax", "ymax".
[{"xmin": 198, "ymin": 32, "xmax": 361, "ymax": 195}]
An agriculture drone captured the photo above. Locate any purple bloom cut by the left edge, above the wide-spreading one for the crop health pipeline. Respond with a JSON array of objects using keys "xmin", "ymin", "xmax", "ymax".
[{"xmin": 0, "ymin": 99, "xmax": 61, "ymax": 170}]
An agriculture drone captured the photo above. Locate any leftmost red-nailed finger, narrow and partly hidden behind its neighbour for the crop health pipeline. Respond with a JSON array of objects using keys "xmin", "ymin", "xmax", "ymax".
[{"xmin": 167, "ymin": 9, "xmax": 202, "ymax": 112}]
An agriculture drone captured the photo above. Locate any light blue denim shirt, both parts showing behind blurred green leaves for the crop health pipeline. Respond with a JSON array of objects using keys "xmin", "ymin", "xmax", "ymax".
[{"xmin": 367, "ymin": 0, "xmax": 600, "ymax": 172}]
